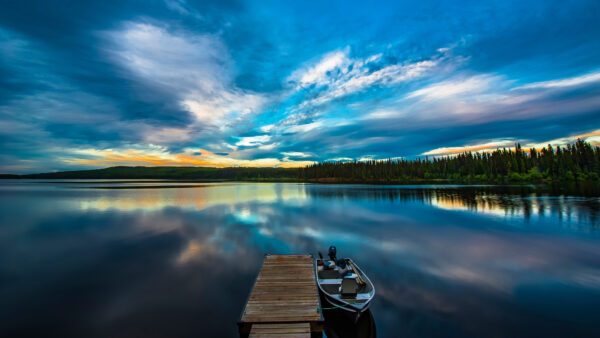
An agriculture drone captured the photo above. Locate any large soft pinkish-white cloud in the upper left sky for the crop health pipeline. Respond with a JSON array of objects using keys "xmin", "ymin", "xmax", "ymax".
[{"xmin": 104, "ymin": 22, "xmax": 265, "ymax": 127}]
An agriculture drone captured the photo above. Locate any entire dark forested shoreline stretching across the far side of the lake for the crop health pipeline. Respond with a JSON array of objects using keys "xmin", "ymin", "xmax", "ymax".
[{"xmin": 0, "ymin": 140, "xmax": 600, "ymax": 185}]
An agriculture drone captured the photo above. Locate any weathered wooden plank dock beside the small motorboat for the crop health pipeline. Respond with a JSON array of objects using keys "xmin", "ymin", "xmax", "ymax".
[{"xmin": 238, "ymin": 255, "xmax": 323, "ymax": 337}]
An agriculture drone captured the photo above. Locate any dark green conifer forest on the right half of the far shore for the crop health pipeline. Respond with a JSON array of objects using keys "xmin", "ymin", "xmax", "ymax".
[{"xmin": 299, "ymin": 140, "xmax": 600, "ymax": 183}]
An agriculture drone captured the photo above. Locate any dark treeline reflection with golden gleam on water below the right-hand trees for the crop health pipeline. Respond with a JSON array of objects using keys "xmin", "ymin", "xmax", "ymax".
[{"xmin": 309, "ymin": 186, "xmax": 600, "ymax": 225}]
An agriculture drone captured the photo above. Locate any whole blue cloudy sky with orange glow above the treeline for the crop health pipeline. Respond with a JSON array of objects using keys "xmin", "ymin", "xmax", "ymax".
[{"xmin": 0, "ymin": 0, "xmax": 600, "ymax": 173}]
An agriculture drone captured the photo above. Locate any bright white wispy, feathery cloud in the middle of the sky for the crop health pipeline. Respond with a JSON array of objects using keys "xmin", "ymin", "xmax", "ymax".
[{"xmin": 260, "ymin": 47, "xmax": 454, "ymax": 151}]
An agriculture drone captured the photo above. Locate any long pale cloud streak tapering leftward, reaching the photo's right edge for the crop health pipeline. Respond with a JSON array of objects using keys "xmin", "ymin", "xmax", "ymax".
[{"xmin": 361, "ymin": 72, "xmax": 600, "ymax": 128}]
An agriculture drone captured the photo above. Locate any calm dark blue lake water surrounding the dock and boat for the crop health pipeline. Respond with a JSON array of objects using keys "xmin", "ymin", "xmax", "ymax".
[{"xmin": 0, "ymin": 181, "xmax": 600, "ymax": 337}]
